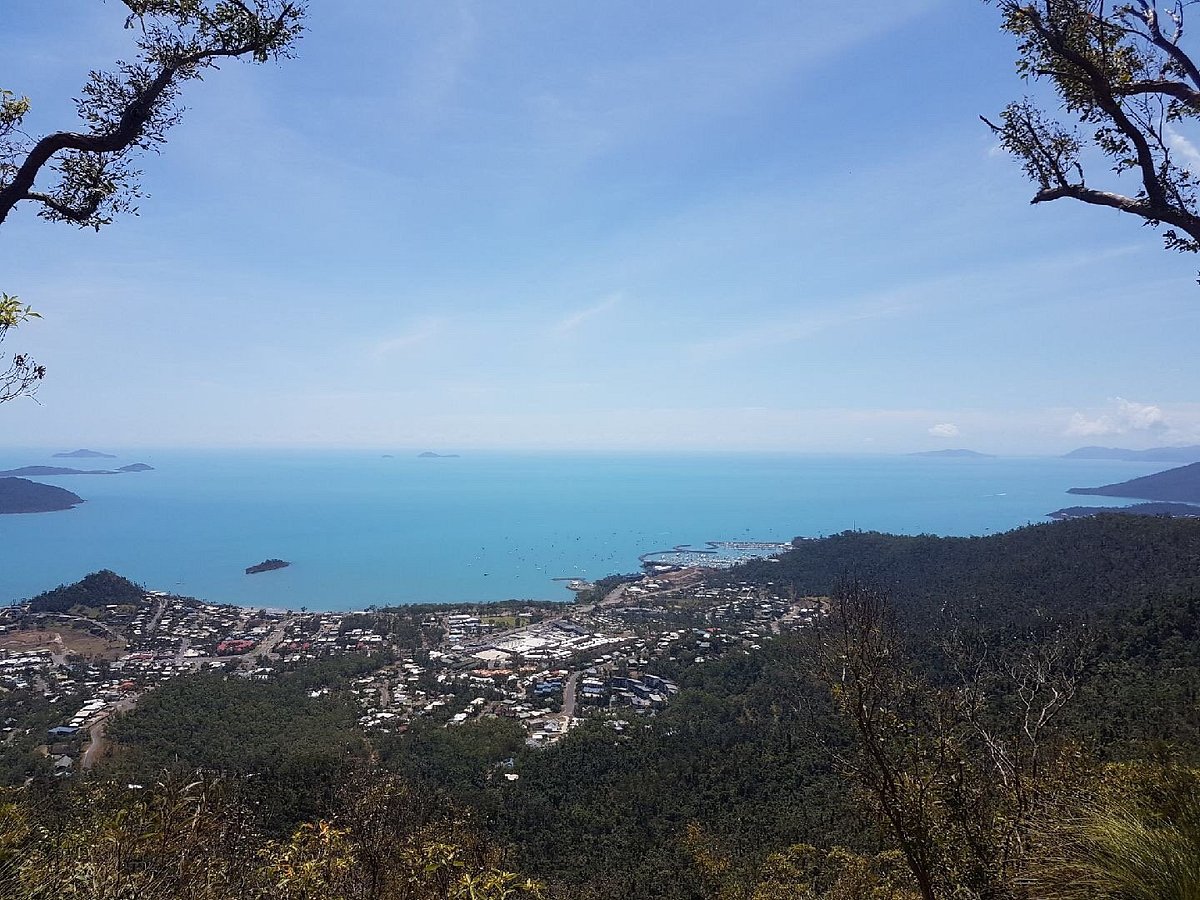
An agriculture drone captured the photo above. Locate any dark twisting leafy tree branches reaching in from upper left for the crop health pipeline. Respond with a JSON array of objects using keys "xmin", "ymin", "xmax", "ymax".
[{"xmin": 0, "ymin": 0, "xmax": 305, "ymax": 403}]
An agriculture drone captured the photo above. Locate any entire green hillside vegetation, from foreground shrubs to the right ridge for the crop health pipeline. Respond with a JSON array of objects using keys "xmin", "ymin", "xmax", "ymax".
[{"xmin": 0, "ymin": 516, "xmax": 1200, "ymax": 900}]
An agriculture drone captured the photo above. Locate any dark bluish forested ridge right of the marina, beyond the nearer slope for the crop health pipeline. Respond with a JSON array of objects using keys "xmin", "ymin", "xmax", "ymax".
[{"xmin": 724, "ymin": 515, "xmax": 1200, "ymax": 624}]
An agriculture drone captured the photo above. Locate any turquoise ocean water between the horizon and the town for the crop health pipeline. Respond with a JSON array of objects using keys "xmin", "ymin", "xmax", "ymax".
[{"xmin": 0, "ymin": 450, "xmax": 1169, "ymax": 610}]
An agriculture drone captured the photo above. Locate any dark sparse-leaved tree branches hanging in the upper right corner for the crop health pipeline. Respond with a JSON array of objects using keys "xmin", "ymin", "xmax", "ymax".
[{"xmin": 984, "ymin": 0, "xmax": 1200, "ymax": 264}]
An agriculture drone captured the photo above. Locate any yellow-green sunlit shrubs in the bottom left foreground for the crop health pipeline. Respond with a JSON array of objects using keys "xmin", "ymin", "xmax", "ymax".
[{"xmin": 0, "ymin": 775, "xmax": 540, "ymax": 900}]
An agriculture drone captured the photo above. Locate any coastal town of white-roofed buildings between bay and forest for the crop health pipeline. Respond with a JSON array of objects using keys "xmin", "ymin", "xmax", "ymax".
[{"xmin": 0, "ymin": 566, "xmax": 821, "ymax": 776}]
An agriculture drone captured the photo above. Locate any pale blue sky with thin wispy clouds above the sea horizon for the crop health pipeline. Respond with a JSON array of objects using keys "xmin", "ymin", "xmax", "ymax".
[{"xmin": 0, "ymin": 0, "xmax": 1200, "ymax": 454}]
